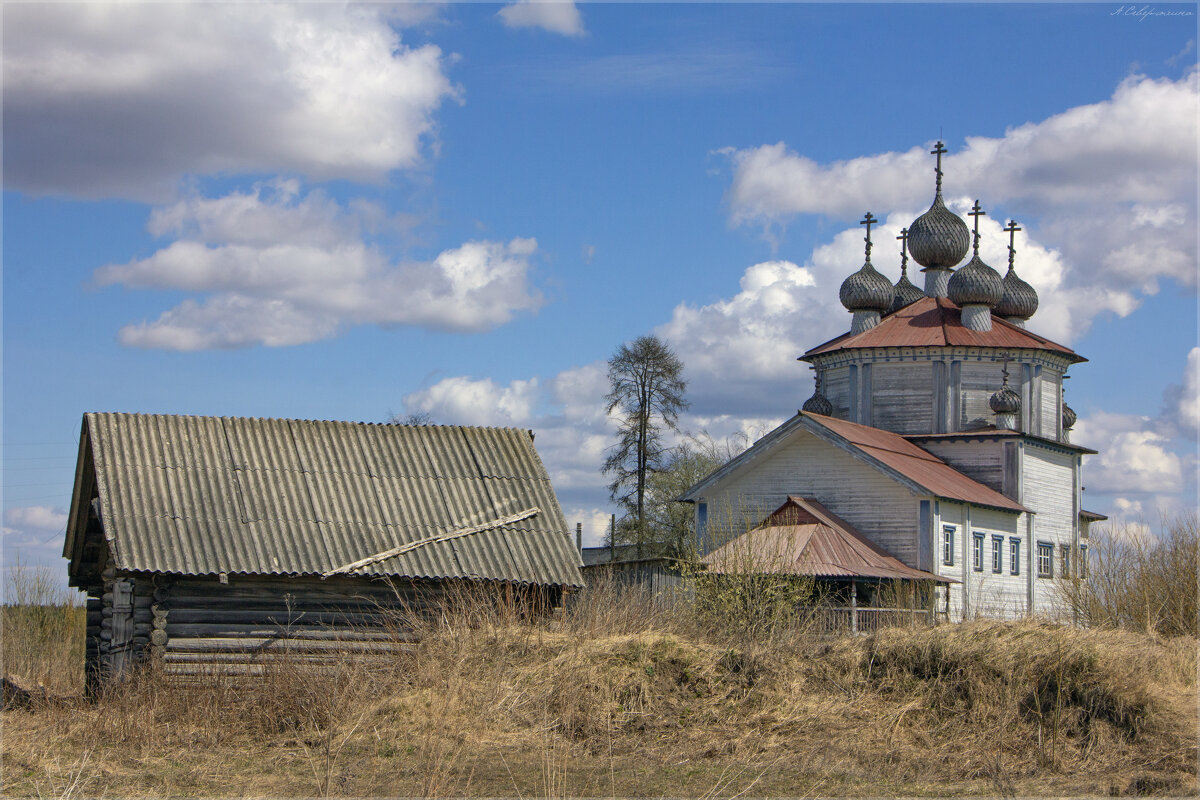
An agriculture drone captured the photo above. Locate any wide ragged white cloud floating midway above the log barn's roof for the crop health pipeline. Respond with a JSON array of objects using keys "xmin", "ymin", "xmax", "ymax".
[{"xmin": 94, "ymin": 181, "xmax": 542, "ymax": 350}]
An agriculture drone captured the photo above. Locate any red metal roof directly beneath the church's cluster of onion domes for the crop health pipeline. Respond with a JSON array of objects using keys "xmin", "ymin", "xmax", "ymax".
[{"xmin": 800, "ymin": 297, "xmax": 1087, "ymax": 362}]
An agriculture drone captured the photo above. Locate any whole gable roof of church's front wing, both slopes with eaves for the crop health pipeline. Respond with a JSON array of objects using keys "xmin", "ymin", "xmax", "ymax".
[{"xmin": 680, "ymin": 411, "xmax": 1028, "ymax": 513}]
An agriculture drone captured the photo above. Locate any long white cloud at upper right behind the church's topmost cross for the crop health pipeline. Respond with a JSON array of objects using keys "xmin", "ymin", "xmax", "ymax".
[{"xmin": 724, "ymin": 68, "xmax": 1200, "ymax": 342}]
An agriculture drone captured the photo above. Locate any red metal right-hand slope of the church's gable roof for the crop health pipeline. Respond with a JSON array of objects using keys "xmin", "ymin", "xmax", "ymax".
[{"xmin": 802, "ymin": 413, "xmax": 1028, "ymax": 512}]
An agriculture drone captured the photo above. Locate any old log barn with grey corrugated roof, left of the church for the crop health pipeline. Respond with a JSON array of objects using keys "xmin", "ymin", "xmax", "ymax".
[{"xmin": 64, "ymin": 413, "xmax": 582, "ymax": 685}]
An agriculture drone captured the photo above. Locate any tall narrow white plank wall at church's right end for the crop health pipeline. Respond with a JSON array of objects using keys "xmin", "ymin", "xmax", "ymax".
[{"xmin": 1021, "ymin": 444, "xmax": 1079, "ymax": 615}]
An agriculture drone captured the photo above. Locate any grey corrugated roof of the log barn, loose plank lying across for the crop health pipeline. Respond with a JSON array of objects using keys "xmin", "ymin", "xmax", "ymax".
[{"xmin": 64, "ymin": 414, "xmax": 582, "ymax": 587}]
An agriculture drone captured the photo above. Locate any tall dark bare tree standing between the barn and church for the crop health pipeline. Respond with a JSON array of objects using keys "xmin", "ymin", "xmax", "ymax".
[{"xmin": 604, "ymin": 336, "xmax": 688, "ymax": 555}]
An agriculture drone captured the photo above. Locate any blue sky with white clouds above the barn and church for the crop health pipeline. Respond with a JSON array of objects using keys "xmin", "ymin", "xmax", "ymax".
[{"xmin": 2, "ymin": 2, "xmax": 1200, "ymax": 587}]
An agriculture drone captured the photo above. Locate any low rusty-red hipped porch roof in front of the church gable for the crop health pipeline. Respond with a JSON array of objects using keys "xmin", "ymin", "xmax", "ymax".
[{"xmin": 701, "ymin": 495, "xmax": 955, "ymax": 583}]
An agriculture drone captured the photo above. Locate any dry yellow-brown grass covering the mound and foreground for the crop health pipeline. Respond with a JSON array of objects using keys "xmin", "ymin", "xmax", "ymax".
[{"xmin": 4, "ymin": 573, "xmax": 1196, "ymax": 796}]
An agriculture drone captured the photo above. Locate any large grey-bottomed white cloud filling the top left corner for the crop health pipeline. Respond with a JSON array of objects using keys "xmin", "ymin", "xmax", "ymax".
[{"xmin": 4, "ymin": 2, "xmax": 460, "ymax": 199}]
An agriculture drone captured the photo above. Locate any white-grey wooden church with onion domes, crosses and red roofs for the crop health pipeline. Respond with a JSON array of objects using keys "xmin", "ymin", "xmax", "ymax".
[{"xmin": 682, "ymin": 142, "xmax": 1104, "ymax": 619}]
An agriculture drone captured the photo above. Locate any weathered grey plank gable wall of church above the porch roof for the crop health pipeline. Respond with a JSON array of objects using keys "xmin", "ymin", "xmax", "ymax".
[{"xmin": 700, "ymin": 431, "xmax": 919, "ymax": 566}]
